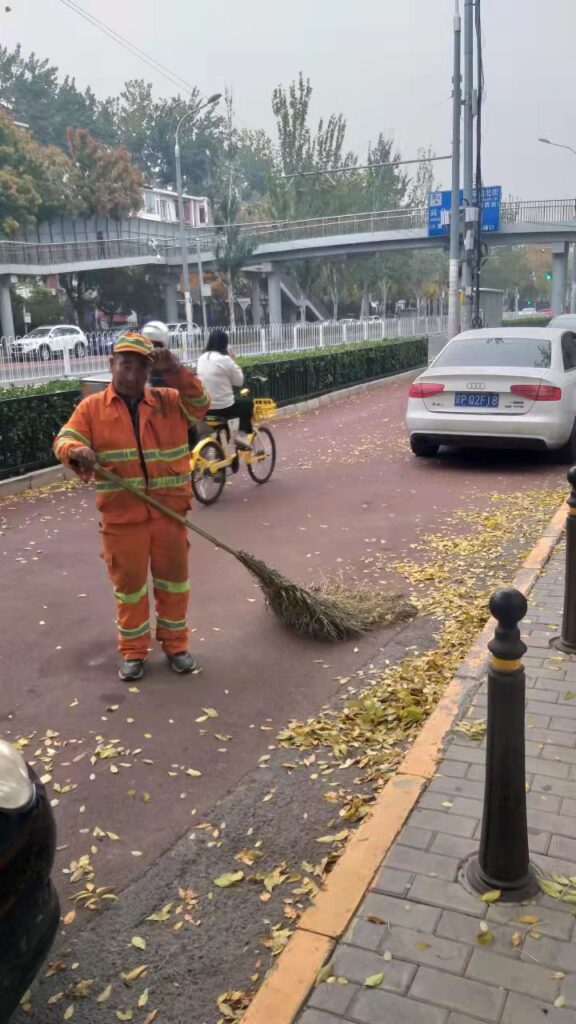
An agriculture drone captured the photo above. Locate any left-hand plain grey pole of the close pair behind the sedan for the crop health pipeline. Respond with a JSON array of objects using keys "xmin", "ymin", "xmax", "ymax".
[{"xmin": 448, "ymin": 0, "xmax": 462, "ymax": 340}]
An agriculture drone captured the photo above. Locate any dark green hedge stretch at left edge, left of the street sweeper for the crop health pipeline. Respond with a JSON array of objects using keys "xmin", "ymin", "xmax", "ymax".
[{"xmin": 0, "ymin": 386, "xmax": 81, "ymax": 480}]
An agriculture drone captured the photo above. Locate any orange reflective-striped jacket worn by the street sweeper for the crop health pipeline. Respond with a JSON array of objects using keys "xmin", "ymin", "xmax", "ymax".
[{"xmin": 54, "ymin": 368, "xmax": 210, "ymax": 522}]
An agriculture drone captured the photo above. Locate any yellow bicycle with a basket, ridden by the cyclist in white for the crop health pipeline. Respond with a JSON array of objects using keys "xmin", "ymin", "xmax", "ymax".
[{"xmin": 190, "ymin": 390, "xmax": 277, "ymax": 505}]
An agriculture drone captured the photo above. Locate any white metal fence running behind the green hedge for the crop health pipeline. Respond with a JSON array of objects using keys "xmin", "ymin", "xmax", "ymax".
[{"xmin": 0, "ymin": 316, "xmax": 448, "ymax": 385}]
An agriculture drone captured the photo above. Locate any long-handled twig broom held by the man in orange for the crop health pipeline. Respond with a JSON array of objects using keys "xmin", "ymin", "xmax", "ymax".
[{"xmin": 96, "ymin": 466, "xmax": 416, "ymax": 640}]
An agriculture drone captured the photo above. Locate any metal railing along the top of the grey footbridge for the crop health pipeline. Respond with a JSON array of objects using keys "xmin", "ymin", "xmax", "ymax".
[{"xmin": 0, "ymin": 199, "xmax": 576, "ymax": 266}]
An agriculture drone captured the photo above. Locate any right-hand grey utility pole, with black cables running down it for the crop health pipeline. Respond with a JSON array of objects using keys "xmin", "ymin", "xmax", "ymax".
[{"xmin": 462, "ymin": 0, "xmax": 476, "ymax": 331}]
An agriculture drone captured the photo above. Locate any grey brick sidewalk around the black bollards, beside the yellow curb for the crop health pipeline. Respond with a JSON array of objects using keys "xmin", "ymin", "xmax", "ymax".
[{"xmin": 298, "ymin": 550, "xmax": 576, "ymax": 1024}]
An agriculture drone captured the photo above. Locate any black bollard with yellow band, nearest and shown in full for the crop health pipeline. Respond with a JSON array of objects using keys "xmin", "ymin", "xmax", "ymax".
[{"xmin": 466, "ymin": 590, "xmax": 539, "ymax": 902}]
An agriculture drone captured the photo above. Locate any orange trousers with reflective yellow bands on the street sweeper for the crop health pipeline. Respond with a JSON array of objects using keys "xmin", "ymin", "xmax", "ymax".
[{"xmin": 100, "ymin": 516, "xmax": 190, "ymax": 659}]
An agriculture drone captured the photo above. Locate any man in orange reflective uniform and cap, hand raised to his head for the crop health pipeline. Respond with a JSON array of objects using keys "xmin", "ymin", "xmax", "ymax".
[{"xmin": 54, "ymin": 332, "xmax": 210, "ymax": 682}]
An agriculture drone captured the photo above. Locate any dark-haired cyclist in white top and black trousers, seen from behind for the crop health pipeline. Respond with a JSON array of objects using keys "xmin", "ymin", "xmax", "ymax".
[{"xmin": 196, "ymin": 328, "xmax": 254, "ymax": 450}]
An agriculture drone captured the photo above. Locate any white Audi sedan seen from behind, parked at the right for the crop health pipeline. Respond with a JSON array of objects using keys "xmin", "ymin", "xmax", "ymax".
[{"xmin": 406, "ymin": 327, "xmax": 576, "ymax": 462}]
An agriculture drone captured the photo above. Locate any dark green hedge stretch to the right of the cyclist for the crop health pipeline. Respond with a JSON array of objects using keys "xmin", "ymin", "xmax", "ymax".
[{"xmin": 240, "ymin": 338, "xmax": 427, "ymax": 406}]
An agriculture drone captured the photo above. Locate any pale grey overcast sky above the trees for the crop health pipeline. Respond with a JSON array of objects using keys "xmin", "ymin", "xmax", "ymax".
[{"xmin": 0, "ymin": 0, "xmax": 576, "ymax": 199}]
